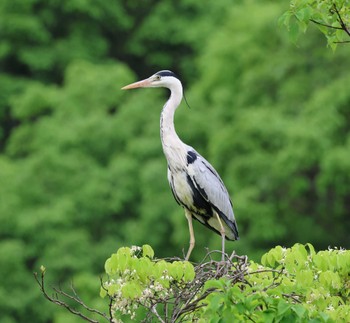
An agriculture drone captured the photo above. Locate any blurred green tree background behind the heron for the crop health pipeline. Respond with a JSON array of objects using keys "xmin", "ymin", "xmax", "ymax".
[{"xmin": 0, "ymin": 0, "xmax": 350, "ymax": 323}]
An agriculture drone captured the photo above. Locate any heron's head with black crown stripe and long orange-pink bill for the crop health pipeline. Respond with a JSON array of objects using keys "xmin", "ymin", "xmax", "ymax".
[{"xmin": 122, "ymin": 70, "xmax": 182, "ymax": 90}]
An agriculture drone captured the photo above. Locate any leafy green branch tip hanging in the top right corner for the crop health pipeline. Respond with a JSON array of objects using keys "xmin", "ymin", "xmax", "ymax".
[{"xmin": 280, "ymin": 0, "xmax": 350, "ymax": 50}]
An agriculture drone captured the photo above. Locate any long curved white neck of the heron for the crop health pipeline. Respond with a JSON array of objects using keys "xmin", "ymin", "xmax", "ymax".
[{"xmin": 160, "ymin": 83, "xmax": 186, "ymax": 167}]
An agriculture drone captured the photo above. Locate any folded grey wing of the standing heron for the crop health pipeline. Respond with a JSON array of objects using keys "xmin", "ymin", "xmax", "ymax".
[{"xmin": 188, "ymin": 149, "xmax": 238, "ymax": 239}]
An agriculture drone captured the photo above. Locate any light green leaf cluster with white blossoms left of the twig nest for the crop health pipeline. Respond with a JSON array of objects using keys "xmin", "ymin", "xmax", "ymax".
[{"xmin": 100, "ymin": 245, "xmax": 195, "ymax": 321}]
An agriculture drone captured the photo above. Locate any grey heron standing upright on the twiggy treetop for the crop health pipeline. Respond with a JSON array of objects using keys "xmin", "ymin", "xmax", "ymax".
[{"xmin": 122, "ymin": 70, "xmax": 239, "ymax": 260}]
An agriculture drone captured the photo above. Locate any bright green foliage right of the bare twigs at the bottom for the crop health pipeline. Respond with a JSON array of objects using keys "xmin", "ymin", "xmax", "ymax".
[{"xmin": 200, "ymin": 244, "xmax": 350, "ymax": 322}]
